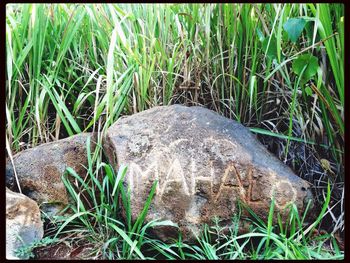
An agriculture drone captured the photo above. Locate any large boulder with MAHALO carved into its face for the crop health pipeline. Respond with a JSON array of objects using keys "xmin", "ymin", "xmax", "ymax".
[{"xmin": 105, "ymin": 105, "xmax": 312, "ymax": 240}]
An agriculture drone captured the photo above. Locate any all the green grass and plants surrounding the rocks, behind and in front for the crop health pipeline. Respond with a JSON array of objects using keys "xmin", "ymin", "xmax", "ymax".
[{"xmin": 6, "ymin": 4, "xmax": 344, "ymax": 258}]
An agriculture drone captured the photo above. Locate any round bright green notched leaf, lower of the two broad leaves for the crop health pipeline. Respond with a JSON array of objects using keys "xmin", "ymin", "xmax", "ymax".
[{"xmin": 292, "ymin": 54, "xmax": 318, "ymax": 81}]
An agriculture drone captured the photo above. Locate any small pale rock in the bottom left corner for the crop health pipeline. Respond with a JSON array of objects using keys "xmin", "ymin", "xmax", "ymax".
[{"xmin": 6, "ymin": 188, "xmax": 44, "ymax": 259}]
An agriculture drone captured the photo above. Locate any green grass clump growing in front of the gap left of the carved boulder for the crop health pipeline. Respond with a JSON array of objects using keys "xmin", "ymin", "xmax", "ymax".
[{"xmin": 47, "ymin": 138, "xmax": 174, "ymax": 259}]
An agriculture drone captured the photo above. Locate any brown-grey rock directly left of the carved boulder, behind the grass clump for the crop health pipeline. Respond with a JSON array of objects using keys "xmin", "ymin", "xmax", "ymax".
[{"xmin": 6, "ymin": 133, "xmax": 94, "ymax": 214}]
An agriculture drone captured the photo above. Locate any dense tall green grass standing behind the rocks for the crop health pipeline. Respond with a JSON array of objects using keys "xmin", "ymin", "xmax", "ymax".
[{"xmin": 6, "ymin": 4, "xmax": 344, "ymax": 151}]
